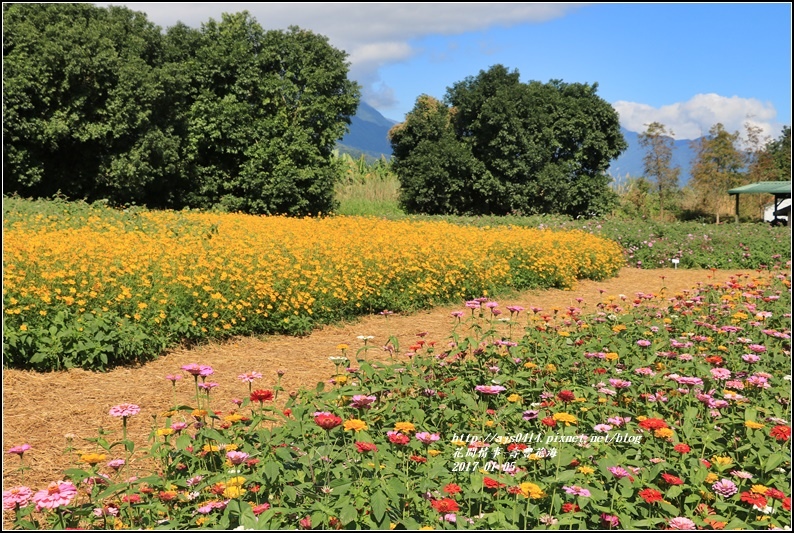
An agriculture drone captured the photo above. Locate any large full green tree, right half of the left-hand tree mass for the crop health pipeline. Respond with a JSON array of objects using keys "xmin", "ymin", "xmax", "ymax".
[{"xmin": 181, "ymin": 12, "xmax": 360, "ymax": 215}]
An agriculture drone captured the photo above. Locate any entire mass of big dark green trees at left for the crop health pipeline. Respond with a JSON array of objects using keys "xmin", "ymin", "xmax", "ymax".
[{"xmin": 3, "ymin": 4, "xmax": 360, "ymax": 215}]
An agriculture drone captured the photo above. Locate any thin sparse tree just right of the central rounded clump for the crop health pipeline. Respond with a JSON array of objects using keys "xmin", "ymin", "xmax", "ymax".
[{"xmin": 639, "ymin": 122, "xmax": 681, "ymax": 219}]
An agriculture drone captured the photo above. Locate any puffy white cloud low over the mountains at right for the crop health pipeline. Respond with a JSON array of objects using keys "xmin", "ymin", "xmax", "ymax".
[{"xmin": 612, "ymin": 93, "xmax": 781, "ymax": 139}]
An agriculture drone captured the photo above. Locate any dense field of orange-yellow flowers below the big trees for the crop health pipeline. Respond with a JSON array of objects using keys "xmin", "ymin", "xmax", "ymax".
[{"xmin": 3, "ymin": 195, "xmax": 624, "ymax": 370}]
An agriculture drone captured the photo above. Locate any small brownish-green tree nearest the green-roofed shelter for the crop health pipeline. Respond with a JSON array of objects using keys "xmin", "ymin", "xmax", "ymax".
[{"xmin": 691, "ymin": 123, "xmax": 745, "ymax": 224}]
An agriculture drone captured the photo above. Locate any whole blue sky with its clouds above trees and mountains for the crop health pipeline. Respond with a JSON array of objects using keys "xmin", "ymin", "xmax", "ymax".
[{"xmin": 98, "ymin": 3, "xmax": 792, "ymax": 139}]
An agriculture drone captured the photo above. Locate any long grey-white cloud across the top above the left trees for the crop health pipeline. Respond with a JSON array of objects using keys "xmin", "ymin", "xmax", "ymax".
[{"xmin": 96, "ymin": 2, "xmax": 583, "ymax": 107}]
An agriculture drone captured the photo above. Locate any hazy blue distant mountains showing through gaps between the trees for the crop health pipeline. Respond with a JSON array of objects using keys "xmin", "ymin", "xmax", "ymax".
[{"xmin": 337, "ymin": 102, "xmax": 695, "ymax": 187}]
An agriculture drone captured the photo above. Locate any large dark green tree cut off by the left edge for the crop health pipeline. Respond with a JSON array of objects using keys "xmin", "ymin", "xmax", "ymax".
[{"xmin": 3, "ymin": 4, "xmax": 180, "ymax": 202}]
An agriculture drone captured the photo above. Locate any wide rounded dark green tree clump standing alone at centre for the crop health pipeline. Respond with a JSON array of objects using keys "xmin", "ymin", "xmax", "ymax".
[{"xmin": 391, "ymin": 65, "xmax": 626, "ymax": 216}]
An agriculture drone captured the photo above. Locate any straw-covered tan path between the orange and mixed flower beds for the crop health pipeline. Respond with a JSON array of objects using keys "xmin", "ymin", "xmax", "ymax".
[{"xmin": 3, "ymin": 268, "xmax": 739, "ymax": 489}]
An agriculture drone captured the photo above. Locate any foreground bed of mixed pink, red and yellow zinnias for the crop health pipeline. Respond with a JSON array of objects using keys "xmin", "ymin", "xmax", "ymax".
[{"xmin": 3, "ymin": 262, "xmax": 791, "ymax": 530}]
